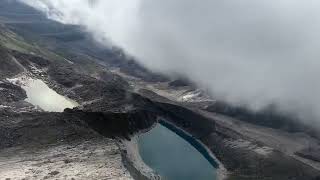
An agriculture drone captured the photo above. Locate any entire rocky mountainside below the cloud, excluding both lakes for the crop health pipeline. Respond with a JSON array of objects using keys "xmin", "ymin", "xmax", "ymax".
[{"xmin": 0, "ymin": 1, "xmax": 320, "ymax": 180}]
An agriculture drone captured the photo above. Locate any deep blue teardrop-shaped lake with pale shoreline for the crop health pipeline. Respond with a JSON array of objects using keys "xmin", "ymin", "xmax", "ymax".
[{"xmin": 138, "ymin": 124, "xmax": 217, "ymax": 180}]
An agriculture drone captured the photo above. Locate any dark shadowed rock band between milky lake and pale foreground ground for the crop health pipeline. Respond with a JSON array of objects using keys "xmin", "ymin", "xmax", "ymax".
[{"xmin": 0, "ymin": 109, "xmax": 157, "ymax": 149}]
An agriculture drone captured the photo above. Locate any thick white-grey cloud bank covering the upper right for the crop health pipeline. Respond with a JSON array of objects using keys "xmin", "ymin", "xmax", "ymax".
[{"xmin": 21, "ymin": 0, "xmax": 320, "ymax": 122}]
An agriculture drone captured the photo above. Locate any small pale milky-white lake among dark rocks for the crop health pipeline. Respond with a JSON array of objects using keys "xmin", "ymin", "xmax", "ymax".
[{"xmin": 22, "ymin": 79, "xmax": 78, "ymax": 112}]
